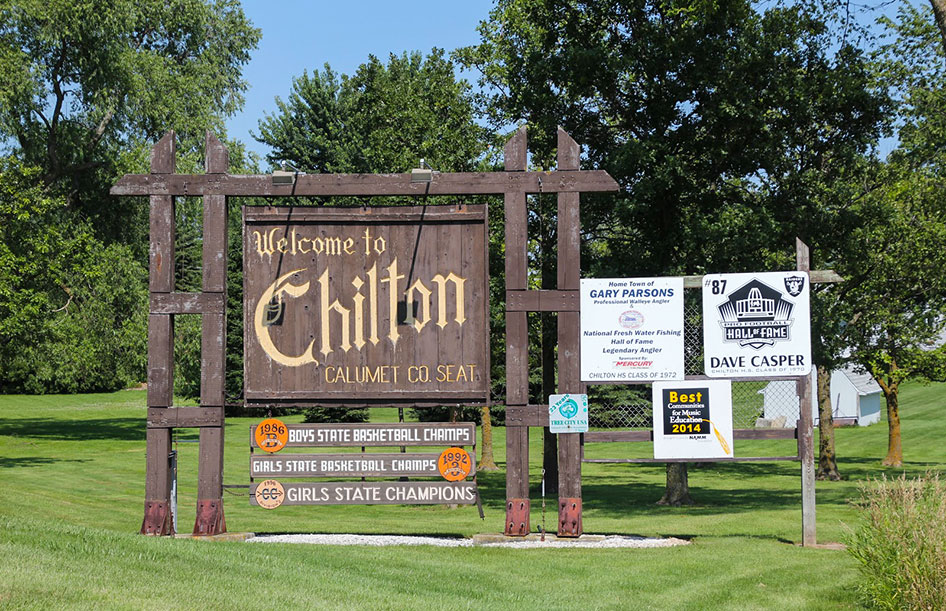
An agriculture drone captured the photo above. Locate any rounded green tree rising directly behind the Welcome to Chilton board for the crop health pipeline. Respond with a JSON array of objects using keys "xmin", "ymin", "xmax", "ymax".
[{"xmin": 257, "ymin": 49, "xmax": 493, "ymax": 452}]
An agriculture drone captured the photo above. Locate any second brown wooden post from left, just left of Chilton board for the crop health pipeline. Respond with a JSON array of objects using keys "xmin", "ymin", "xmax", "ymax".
[{"xmin": 194, "ymin": 131, "xmax": 229, "ymax": 535}]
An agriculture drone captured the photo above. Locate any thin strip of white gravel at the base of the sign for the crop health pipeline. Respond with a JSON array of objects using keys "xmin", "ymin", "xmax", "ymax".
[{"xmin": 247, "ymin": 535, "xmax": 689, "ymax": 549}]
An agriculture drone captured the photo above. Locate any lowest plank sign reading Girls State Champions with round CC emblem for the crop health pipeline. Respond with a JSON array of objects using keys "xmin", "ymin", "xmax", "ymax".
[{"xmin": 250, "ymin": 480, "xmax": 476, "ymax": 509}]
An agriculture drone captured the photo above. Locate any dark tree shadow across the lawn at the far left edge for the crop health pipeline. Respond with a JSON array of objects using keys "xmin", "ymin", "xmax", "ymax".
[{"xmin": 0, "ymin": 418, "xmax": 146, "ymax": 441}]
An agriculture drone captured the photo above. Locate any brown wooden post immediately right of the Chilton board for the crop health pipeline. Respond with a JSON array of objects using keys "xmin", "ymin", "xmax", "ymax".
[{"xmin": 503, "ymin": 127, "xmax": 530, "ymax": 536}]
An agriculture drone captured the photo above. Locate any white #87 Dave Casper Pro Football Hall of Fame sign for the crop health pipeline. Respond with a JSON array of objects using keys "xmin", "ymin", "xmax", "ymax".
[{"xmin": 703, "ymin": 271, "xmax": 811, "ymax": 378}]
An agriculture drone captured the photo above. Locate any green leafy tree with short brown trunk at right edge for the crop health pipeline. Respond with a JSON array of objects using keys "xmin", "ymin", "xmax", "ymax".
[{"xmin": 824, "ymin": 3, "xmax": 946, "ymax": 466}]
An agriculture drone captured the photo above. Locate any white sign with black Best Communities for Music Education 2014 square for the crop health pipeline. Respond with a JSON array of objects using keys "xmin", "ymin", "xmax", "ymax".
[{"xmin": 653, "ymin": 380, "xmax": 733, "ymax": 459}]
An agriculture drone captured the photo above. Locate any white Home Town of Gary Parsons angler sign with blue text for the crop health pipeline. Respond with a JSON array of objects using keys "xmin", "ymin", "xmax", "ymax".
[{"xmin": 581, "ymin": 278, "xmax": 683, "ymax": 382}]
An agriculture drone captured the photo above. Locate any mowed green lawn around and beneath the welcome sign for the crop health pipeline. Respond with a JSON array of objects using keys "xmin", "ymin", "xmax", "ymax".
[{"xmin": 0, "ymin": 385, "xmax": 946, "ymax": 609}]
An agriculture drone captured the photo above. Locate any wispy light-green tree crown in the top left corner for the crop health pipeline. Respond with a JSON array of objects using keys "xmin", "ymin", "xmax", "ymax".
[{"xmin": 0, "ymin": 0, "xmax": 260, "ymax": 217}]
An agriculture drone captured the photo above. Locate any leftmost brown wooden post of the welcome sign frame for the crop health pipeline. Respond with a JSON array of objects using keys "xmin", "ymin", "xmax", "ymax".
[{"xmin": 141, "ymin": 131, "xmax": 177, "ymax": 535}]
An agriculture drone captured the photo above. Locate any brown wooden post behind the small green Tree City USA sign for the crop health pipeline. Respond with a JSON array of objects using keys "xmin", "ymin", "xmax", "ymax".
[{"xmin": 558, "ymin": 127, "xmax": 582, "ymax": 537}]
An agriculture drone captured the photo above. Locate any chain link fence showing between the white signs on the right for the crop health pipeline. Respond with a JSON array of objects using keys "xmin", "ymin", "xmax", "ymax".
[{"xmin": 588, "ymin": 290, "xmax": 799, "ymax": 429}]
